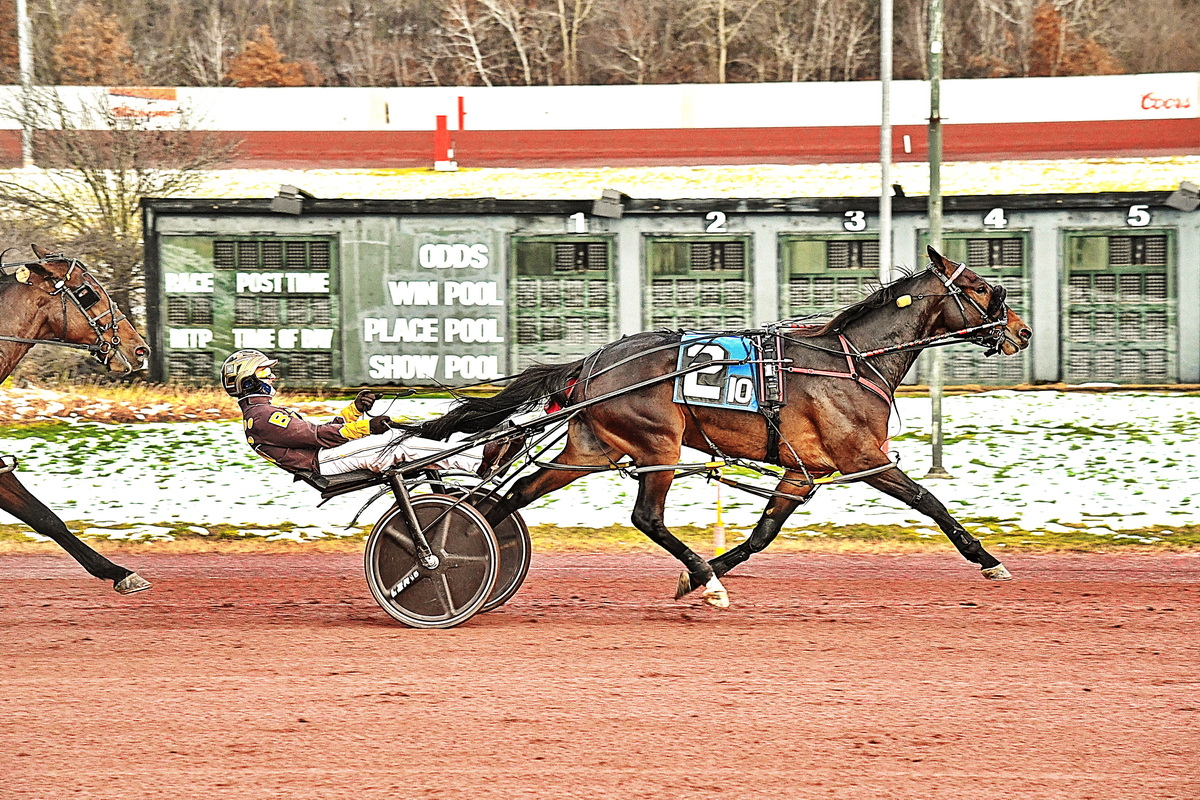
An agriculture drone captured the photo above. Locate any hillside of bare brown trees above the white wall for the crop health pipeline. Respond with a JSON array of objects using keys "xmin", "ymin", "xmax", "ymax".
[{"xmin": 0, "ymin": 0, "xmax": 1200, "ymax": 86}]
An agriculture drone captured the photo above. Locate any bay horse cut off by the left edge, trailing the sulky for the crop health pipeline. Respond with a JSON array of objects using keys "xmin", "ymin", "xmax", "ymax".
[{"xmin": 0, "ymin": 245, "xmax": 150, "ymax": 595}]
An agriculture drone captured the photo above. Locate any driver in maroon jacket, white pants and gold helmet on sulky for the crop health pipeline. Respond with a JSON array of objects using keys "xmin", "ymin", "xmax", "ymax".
[{"xmin": 221, "ymin": 350, "xmax": 504, "ymax": 477}]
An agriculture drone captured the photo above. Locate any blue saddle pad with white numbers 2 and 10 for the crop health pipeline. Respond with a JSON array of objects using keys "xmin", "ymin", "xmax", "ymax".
[{"xmin": 672, "ymin": 333, "xmax": 758, "ymax": 411}]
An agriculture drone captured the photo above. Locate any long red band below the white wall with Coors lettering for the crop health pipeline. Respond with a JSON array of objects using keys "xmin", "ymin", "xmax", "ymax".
[{"xmin": 0, "ymin": 119, "xmax": 1200, "ymax": 169}]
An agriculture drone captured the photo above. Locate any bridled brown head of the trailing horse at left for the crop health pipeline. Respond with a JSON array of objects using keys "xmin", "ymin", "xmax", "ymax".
[{"xmin": 16, "ymin": 245, "xmax": 150, "ymax": 374}]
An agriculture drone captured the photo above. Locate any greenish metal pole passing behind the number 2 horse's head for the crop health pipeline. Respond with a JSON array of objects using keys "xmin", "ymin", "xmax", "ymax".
[{"xmin": 925, "ymin": 0, "xmax": 952, "ymax": 477}]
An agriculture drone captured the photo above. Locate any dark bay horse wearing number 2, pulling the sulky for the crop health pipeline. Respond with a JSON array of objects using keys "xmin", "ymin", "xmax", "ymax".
[{"xmin": 410, "ymin": 248, "xmax": 1032, "ymax": 608}]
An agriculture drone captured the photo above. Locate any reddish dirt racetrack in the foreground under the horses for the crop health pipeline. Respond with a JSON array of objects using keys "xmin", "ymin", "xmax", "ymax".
[{"xmin": 0, "ymin": 553, "xmax": 1200, "ymax": 800}]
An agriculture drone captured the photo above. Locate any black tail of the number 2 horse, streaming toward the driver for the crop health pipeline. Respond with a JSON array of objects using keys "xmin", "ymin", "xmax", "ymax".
[{"xmin": 406, "ymin": 359, "xmax": 586, "ymax": 439}]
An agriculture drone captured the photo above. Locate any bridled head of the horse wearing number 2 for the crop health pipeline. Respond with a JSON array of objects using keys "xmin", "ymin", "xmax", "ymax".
[{"xmin": 929, "ymin": 247, "xmax": 1033, "ymax": 355}]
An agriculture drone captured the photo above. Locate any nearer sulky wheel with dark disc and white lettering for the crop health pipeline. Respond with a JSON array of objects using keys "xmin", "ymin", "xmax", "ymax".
[{"xmin": 365, "ymin": 494, "xmax": 499, "ymax": 627}]
